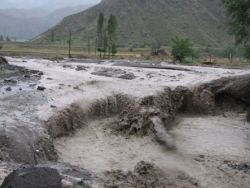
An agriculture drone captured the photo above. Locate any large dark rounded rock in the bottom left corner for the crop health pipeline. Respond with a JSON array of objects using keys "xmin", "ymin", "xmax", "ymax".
[{"xmin": 0, "ymin": 167, "xmax": 62, "ymax": 188}]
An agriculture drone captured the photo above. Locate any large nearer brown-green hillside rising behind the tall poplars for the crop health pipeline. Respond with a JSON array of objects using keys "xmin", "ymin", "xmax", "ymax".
[{"xmin": 32, "ymin": 0, "xmax": 228, "ymax": 46}]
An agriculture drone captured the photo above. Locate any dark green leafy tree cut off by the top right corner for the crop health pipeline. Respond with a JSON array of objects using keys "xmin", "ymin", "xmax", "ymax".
[{"xmin": 222, "ymin": 0, "xmax": 250, "ymax": 59}]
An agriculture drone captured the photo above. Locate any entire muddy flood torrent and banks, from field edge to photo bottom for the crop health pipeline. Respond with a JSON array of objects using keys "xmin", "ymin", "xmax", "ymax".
[{"xmin": 0, "ymin": 58, "xmax": 250, "ymax": 188}]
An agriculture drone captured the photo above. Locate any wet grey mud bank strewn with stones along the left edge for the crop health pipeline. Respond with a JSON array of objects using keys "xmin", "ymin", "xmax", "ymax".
[{"xmin": 0, "ymin": 64, "xmax": 57, "ymax": 164}]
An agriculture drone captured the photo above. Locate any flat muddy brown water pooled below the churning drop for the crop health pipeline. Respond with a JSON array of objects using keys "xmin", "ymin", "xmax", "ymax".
[{"xmin": 54, "ymin": 116, "xmax": 250, "ymax": 188}]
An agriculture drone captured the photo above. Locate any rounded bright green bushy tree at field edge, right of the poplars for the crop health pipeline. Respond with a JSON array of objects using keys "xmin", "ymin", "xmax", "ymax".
[{"xmin": 171, "ymin": 36, "xmax": 194, "ymax": 62}]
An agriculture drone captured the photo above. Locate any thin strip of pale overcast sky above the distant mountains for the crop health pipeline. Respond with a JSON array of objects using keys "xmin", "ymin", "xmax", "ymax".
[{"xmin": 0, "ymin": 0, "xmax": 101, "ymax": 9}]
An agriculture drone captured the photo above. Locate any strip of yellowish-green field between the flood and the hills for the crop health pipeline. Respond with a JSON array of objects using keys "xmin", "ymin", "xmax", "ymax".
[{"xmin": 0, "ymin": 42, "xmax": 249, "ymax": 66}]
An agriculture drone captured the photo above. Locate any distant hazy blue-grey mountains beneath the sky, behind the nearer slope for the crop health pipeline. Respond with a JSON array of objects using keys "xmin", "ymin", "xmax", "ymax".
[{"xmin": 0, "ymin": 5, "xmax": 92, "ymax": 39}]
